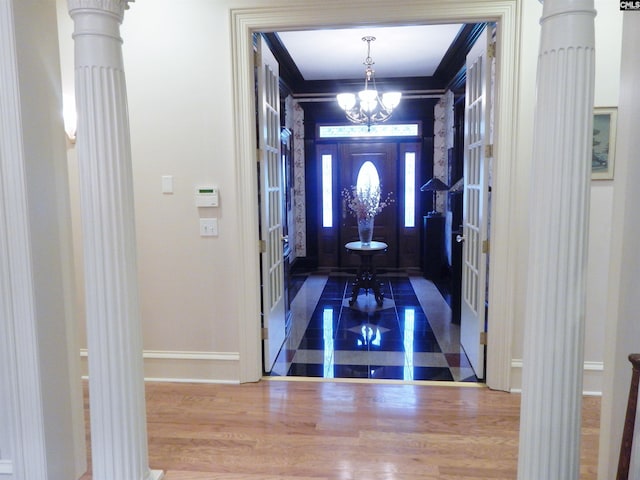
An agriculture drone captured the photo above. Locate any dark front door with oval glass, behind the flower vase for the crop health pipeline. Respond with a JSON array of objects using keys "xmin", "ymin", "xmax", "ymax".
[{"xmin": 338, "ymin": 143, "xmax": 398, "ymax": 267}]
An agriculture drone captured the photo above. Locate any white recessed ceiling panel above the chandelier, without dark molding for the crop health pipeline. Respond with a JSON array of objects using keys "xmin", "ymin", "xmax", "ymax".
[{"xmin": 278, "ymin": 24, "xmax": 463, "ymax": 81}]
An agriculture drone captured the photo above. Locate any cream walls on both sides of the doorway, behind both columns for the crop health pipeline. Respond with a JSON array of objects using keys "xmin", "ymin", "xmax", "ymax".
[{"xmin": 58, "ymin": 0, "xmax": 620, "ymax": 391}]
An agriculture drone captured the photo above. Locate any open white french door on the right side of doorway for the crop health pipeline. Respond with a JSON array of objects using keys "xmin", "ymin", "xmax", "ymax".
[{"xmin": 460, "ymin": 29, "xmax": 491, "ymax": 379}]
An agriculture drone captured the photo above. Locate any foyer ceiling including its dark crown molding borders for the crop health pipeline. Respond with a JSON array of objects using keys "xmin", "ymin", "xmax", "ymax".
[{"xmin": 265, "ymin": 24, "xmax": 484, "ymax": 94}]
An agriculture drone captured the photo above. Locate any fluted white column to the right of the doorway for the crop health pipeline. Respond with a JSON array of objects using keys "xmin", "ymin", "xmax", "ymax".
[{"xmin": 518, "ymin": 0, "xmax": 595, "ymax": 480}]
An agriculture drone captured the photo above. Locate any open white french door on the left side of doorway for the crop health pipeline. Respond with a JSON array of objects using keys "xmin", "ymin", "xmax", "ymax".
[{"xmin": 256, "ymin": 36, "xmax": 286, "ymax": 372}]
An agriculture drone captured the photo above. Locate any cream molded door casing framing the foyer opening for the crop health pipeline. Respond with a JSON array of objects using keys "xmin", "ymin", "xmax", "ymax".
[{"xmin": 231, "ymin": 0, "xmax": 519, "ymax": 389}]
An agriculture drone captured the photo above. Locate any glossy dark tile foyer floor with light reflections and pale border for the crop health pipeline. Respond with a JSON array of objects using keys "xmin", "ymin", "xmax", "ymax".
[{"xmin": 271, "ymin": 274, "xmax": 477, "ymax": 382}]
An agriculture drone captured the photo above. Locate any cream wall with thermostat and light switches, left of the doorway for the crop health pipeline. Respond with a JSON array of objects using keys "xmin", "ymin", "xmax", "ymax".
[{"xmin": 58, "ymin": 0, "xmax": 247, "ymax": 381}]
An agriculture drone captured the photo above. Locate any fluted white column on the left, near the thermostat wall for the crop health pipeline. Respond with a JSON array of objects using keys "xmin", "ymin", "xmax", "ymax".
[{"xmin": 69, "ymin": 0, "xmax": 161, "ymax": 480}]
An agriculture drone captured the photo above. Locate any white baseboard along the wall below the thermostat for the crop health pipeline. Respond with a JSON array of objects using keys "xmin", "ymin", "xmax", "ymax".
[{"xmin": 80, "ymin": 349, "xmax": 240, "ymax": 383}]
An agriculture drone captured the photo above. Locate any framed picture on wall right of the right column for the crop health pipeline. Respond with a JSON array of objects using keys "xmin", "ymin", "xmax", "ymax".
[{"xmin": 591, "ymin": 107, "xmax": 616, "ymax": 180}]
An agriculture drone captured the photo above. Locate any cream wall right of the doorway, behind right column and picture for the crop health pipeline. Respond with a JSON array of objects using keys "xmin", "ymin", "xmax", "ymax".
[{"xmin": 511, "ymin": 0, "xmax": 622, "ymax": 394}]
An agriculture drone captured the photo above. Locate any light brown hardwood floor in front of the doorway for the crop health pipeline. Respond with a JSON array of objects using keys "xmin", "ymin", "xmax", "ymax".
[{"xmin": 83, "ymin": 379, "xmax": 600, "ymax": 480}]
